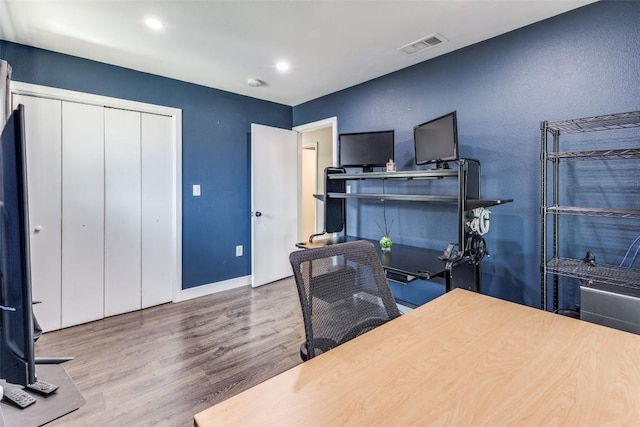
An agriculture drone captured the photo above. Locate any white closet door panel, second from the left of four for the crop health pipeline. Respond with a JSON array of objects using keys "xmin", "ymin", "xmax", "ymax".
[{"xmin": 62, "ymin": 102, "xmax": 104, "ymax": 327}]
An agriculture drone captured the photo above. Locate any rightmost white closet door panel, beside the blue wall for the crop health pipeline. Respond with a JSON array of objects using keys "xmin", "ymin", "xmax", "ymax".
[{"xmin": 142, "ymin": 113, "xmax": 176, "ymax": 308}]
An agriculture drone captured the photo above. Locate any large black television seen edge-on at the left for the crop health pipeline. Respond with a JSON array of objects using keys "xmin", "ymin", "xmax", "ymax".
[{"xmin": 0, "ymin": 105, "xmax": 37, "ymax": 386}]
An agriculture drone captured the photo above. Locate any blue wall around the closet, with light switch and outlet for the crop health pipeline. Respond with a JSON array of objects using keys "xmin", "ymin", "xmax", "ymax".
[{"xmin": 0, "ymin": 41, "xmax": 292, "ymax": 289}]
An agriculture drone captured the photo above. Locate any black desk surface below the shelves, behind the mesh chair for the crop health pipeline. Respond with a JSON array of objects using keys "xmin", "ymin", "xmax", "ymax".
[{"xmin": 296, "ymin": 236, "xmax": 480, "ymax": 292}]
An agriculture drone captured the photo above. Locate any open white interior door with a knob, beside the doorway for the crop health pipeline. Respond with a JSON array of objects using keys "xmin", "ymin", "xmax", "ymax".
[{"xmin": 251, "ymin": 124, "xmax": 298, "ymax": 287}]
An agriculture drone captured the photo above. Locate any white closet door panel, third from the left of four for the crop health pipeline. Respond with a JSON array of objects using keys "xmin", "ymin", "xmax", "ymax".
[{"xmin": 104, "ymin": 108, "xmax": 141, "ymax": 316}]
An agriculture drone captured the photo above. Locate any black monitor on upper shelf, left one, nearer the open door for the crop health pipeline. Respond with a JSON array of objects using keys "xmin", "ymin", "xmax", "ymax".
[{"xmin": 338, "ymin": 130, "xmax": 394, "ymax": 172}]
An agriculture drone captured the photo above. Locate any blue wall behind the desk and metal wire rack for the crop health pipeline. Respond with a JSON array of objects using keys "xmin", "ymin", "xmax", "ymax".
[{"xmin": 293, "ymin": 1, "xmax": 640, "ymax": 306}]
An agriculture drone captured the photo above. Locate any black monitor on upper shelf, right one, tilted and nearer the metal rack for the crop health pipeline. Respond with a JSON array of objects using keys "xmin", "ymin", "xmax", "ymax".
[{"xmin": 413, "ymin": 111, "xmax": 458, "ymax": 169}]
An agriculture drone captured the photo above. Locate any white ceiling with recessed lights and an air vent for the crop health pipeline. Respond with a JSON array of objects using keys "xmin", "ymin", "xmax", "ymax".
[{"xmin": 0, "ymin": 0, "xmax": 594, "ymax": 106}]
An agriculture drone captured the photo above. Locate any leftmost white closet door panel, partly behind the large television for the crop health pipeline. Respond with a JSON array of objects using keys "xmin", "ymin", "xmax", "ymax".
[{"xmin": 13, "ymin": 95, "xmax": 62, "ymax": 332}]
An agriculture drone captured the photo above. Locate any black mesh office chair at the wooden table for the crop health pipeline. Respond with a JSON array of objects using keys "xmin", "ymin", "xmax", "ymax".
[{"xmin": 289, "ymin": 240, "xmax": 400, "ymax": 360}]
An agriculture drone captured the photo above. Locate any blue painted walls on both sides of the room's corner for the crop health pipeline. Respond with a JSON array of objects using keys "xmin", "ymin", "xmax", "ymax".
[{"xmin": 0, "ymin": 1, "xmax": 640, "ymax": 306}]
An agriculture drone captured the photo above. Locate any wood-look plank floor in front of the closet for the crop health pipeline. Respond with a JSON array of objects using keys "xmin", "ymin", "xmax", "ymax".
[{"xmin": 36, "ymin": 278, "xmax": 304, "ymax": 427}]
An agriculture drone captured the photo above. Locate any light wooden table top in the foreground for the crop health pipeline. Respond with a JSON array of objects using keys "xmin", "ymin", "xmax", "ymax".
[{"xmin": 194, "ymin": 289, "xmax": 640, "ymax": 427}]
